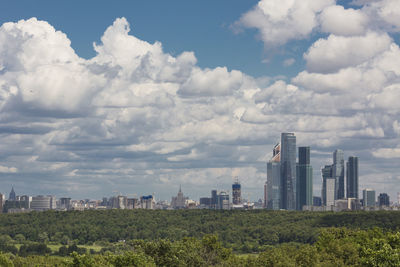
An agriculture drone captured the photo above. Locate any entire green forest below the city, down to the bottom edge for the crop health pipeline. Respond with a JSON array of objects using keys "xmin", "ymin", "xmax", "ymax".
[{"xmin": 0, "ymin": 210, "xmax": 400, "ymax": 266}]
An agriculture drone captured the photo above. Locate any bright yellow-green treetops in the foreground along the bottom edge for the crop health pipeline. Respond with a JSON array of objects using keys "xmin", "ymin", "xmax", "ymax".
[{"xmin": 0, "ymin": 228, "xmax": 400, "ymax": 267}]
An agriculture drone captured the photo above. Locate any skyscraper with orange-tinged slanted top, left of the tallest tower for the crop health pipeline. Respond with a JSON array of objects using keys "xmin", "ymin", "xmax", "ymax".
[{"xmin": 266, "ymin": 143, "xmax": 281, "ymax": 210}]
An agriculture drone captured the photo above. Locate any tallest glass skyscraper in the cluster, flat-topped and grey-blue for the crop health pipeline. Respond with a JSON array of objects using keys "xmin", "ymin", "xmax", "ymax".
[{"xmin": 280, "ymin": 133, "xmax": 297, "ymax": 210}]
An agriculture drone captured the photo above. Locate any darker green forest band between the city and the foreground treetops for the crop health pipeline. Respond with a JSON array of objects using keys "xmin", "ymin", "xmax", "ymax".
[{"xmin": 0, "ymin": 210, "xmax": 400, "ymax": 253}]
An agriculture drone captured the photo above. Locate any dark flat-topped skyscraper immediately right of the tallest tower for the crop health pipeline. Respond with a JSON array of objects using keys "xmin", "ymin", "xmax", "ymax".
[{"xmin": 296, "ymin": 146, "xmax": 313, "ymax": 210}]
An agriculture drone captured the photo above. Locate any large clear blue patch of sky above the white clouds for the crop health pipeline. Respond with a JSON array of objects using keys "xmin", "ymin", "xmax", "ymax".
[{"xmin": 0, "ymin": 0, "xmax": 308, "ymax": 77}]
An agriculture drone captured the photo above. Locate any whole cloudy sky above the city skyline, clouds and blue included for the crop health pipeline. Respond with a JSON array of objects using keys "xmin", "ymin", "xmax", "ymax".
[{"xmin": 0, "ymin": 0, "xmax": 400, "ymax": 201}]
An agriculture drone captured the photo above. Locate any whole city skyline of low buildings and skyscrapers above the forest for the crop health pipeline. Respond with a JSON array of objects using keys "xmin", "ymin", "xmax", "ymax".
[{"xmin": 0, "ymin": 133, "xmax": 400, "ymax": 213}]
